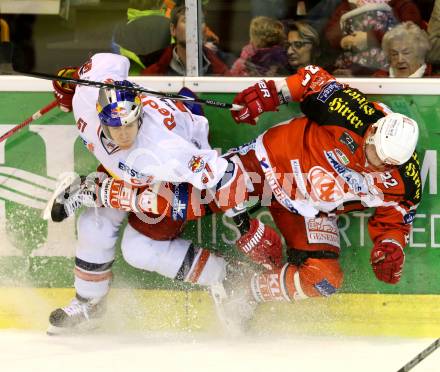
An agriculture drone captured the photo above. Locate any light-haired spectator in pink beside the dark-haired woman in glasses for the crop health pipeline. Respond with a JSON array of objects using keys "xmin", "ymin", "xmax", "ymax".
[{"xmin": 230, "ymin": 16, "xmax": 288, "ymax": 76}]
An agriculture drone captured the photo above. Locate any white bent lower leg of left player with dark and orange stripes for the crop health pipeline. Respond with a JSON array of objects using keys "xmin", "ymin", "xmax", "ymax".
[{"xmin": 121, "ymin": 222, "xmax": 226, "ymax": 285}]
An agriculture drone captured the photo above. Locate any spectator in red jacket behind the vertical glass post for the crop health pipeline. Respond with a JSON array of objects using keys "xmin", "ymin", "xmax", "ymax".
[{"xmin": 139, "ymin": 5, "xmax": 229, "ymax": 76}]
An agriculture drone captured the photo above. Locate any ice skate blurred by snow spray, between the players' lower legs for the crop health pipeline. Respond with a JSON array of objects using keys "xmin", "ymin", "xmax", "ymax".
[{"xmin": 210, "ymin": 263, "xmax": 257, "ymax": 336}]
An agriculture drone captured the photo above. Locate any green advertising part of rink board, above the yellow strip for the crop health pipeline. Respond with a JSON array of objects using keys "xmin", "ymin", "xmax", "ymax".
[{"xmin": 0, "ymin": 89, "xmax": 440, "ymax": 294}]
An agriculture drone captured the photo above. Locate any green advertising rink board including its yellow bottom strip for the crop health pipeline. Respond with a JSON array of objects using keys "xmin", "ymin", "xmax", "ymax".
[{"xmin": 0, "ymin": 87, "xmax": 440, "ymax": 337}]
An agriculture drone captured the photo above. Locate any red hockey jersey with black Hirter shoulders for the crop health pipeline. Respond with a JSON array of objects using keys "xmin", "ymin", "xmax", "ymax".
[{"xmin": 255, "ymin": 66, "xmax": 422, "ymax": 247}]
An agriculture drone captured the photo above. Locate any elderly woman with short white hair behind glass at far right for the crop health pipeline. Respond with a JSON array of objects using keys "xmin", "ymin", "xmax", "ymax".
[{"xmin": 374, "ymin": 21, "xmax": 432, "ymax": 78}]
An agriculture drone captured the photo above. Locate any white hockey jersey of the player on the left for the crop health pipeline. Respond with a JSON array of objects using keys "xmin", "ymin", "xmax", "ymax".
[{"xmin": 73, "ymin": 53, "xmax": 227, "ymax": 189}]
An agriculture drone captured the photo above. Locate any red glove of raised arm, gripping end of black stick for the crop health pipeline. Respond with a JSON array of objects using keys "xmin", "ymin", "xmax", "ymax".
[{"xmin": 231, "ymin": 80, "xmax": 280, "ymax": 125}]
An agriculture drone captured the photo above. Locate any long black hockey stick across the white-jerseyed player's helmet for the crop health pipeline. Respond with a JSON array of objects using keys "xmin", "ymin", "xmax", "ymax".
[{"xmin": 11, "ymin": 71, "xmax": 242, "ymax": 110}]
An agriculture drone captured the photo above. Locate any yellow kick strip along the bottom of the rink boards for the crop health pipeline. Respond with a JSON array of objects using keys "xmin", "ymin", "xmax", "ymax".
[{"xmin": 0, "ymin": 288, "xmax": 440, "ymax": 338}]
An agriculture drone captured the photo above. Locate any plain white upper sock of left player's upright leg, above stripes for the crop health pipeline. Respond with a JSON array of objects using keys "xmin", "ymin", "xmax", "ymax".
[{"xmin": 76, "ymin": 208, "xmax": 126, "ymax": 262}]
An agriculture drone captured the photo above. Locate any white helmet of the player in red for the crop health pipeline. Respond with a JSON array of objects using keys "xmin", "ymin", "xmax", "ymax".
[{"xmin": 367, "ymin": 113, "xmax": 419, "ymax": 165}]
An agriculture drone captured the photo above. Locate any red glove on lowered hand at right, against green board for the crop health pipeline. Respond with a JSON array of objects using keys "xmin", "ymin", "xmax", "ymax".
[{"xmin": 370, "ymin": 241, "xmax": 405, "ymax": 284}]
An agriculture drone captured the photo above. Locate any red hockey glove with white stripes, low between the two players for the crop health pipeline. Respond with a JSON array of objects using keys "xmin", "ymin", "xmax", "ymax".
[{"xmin": 235, "ymin": 218, "xmax": 283, "ymax": 268}]
